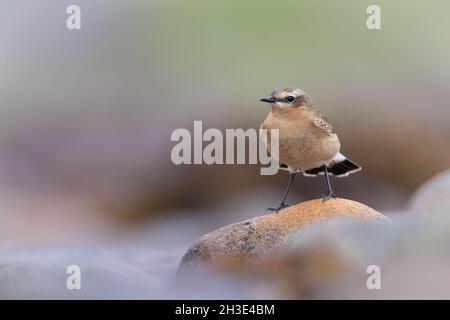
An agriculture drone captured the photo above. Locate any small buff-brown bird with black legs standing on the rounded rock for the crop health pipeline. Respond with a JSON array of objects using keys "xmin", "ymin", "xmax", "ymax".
[{"xmin": 260, "ymin": 87, "xmax": 361, "ymax": 212}]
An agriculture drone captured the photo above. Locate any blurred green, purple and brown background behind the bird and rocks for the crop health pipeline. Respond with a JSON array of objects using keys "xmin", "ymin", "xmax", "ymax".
[{"xmin": 0, "ymin": 0, "xmax": 450, "ymax": 300}]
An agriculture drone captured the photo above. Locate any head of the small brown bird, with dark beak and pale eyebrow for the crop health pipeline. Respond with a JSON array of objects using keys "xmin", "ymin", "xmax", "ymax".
[{"xmin": 259, "ymin": 87, "xmax": 313, "ymax": 109}]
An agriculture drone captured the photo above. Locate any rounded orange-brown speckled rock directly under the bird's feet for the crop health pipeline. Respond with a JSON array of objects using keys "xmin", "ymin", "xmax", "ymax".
[{"xmin": 180, "ymin": 198, "xmax": 385, "ymax": 270}]
